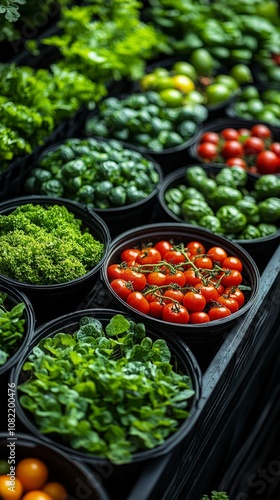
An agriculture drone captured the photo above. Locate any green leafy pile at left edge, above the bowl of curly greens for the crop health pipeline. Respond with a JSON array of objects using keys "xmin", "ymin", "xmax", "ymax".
[{"xmin": 0, "ymin": 64, "xmax": 100, "ymax": 172}]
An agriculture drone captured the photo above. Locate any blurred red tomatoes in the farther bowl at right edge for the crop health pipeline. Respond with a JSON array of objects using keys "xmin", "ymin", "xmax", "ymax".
[{"xmin": 197, "ymin": 123, "xmax": 280, "ymax": 175}]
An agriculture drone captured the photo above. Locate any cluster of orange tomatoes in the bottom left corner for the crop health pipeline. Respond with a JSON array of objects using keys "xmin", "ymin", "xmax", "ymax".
[{"xmin": 0, "ymin": 457, "xmax": 67, "ymax": 500}]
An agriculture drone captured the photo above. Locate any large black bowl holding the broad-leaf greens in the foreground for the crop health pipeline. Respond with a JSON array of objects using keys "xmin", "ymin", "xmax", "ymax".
[{"xmin": 11, "ymin": 308, "xmax": 201, "ymax": 474}]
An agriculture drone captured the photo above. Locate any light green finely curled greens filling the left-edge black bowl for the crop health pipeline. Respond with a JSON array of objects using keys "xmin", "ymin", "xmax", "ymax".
[{"xmin": 0, "ymin": 203, "xmax": 104, "ymax": 285}]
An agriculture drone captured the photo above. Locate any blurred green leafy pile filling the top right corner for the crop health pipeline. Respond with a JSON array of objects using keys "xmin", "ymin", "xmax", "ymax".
[{"xmin": 145, "ymin": 0, "xmax": 280, "ymax": 69}]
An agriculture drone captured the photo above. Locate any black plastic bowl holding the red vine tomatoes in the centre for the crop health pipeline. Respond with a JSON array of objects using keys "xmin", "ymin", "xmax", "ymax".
[{"xmin": 101, "ymin": 223, "xmax": 260, "ymax": 348}]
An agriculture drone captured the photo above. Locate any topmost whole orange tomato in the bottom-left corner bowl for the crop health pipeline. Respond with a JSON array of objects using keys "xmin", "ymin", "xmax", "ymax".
[{"xmin": 16, "ymin": 457, "xmax": 49, "ymax": 491}]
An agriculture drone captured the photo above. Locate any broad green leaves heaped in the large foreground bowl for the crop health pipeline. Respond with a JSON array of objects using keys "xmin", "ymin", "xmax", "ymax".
[{"xmin": 19, "ymin": 314, "xmax": 194, "ymax": 464}]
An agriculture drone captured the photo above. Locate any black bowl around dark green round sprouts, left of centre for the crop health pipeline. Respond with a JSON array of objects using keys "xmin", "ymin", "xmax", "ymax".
[{"xmin": 22, "ymin": 137, "xmax": 163, "ymax": 237}]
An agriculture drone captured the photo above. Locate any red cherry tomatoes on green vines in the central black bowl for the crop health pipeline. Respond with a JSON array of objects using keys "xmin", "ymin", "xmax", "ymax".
[{"xmin": 107, "ymin": 240, "xmax": 245, "ymax": 324}]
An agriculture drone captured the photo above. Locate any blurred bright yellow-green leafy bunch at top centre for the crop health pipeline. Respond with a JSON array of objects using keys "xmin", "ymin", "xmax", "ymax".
[{"xmin": 43, "ymin": 0, "xmax": 165, "ymax": 84}]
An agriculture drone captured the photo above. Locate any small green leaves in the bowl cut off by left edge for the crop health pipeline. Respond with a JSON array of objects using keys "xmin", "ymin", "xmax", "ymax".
[{"xmin": 0, "ymin": 291, "xmax": 25, "ymax": 366}]
